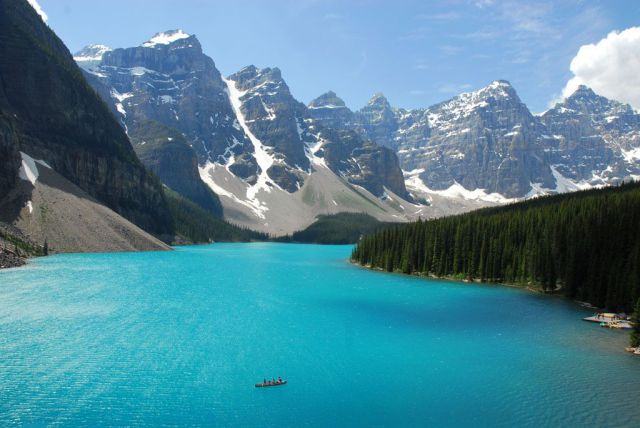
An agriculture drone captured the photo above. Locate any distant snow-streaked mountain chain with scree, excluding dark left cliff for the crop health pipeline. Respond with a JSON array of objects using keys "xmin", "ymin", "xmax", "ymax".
[{"xmin": 75, "ymin": 30, "xmax": 640, "ymax": 235}]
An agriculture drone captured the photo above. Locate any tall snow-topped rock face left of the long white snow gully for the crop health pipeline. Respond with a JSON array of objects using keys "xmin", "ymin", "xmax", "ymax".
[{"xmin": 82, "ymin": 30, "xmax": 257, "ymax": 179}]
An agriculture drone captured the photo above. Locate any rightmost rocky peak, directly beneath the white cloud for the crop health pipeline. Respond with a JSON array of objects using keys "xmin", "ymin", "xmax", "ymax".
[{"xmin": 541, "ymin": 86, "xmax": 640, "ymax": 185}]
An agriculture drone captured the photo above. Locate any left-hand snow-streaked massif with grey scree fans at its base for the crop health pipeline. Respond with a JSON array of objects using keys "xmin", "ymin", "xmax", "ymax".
[{"xmin": 77, "ymin": 30, "xmax": 424, "ymax": 233}]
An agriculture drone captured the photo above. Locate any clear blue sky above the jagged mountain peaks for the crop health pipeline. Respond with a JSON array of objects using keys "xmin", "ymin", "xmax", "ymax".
[{"xmin": 39, "ymin": 0, "xmax": 640, "ymax": 112}]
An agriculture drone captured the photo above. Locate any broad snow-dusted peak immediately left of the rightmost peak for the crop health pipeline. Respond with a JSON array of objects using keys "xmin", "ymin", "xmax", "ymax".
[{"xmin": 410, "ymin": 81, "xmax": 554, "ymax": 198}]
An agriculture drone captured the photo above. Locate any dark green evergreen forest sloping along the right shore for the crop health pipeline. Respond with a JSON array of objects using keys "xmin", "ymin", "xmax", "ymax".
[{"xmin": 352, "ymin": 183, "xmax": 640, "ymax": 311}]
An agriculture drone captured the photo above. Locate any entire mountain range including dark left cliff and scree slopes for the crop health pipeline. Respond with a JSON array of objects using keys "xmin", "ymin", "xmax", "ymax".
[{"xmin": 0, "ymin": 0, "xmax": 640, "ymax": 252}]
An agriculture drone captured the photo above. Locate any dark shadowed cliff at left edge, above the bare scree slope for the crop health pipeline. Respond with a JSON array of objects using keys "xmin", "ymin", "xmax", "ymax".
[{"xmin": 0, "ymin": 0, "xmax": 172, "ymax": 234}]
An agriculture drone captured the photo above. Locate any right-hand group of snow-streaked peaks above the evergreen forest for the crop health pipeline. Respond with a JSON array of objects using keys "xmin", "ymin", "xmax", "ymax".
[{"xmin": 350, "ymin": 80, "xmax": 640, "ymax": 203}]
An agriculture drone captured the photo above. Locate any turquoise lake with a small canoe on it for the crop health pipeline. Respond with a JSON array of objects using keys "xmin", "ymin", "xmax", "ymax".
[{"xmin": 0, "ymin": 243, "xmax": 640, "ymax": 427}]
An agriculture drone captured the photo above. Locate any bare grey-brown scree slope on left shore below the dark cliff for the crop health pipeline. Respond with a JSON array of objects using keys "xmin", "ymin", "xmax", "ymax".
[{"xmin": 0, "ymin": 153, "xmax": 169, "ymax": 253}]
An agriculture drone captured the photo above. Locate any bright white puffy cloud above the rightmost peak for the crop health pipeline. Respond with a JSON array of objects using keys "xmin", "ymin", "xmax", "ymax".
[{"xmin": 562, "ymin": 27, "xmax": 640, "ymax": 109}]
